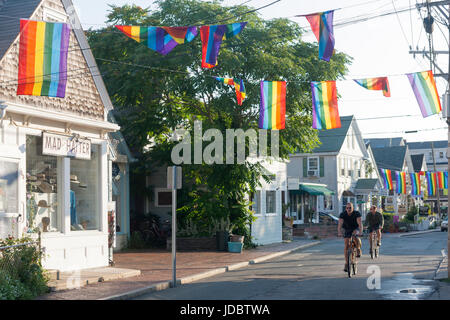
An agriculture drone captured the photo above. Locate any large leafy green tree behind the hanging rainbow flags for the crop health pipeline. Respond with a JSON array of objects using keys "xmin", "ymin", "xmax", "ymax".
[{"xmin": 88, "ymin": 0, "xmax": 350, "ymax": 245}]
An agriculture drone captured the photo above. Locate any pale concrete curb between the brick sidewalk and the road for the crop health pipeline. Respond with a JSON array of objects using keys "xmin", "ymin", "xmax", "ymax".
[{"xmin": 97, "ymin": 241, "xmax": 320, "ymax": 300}]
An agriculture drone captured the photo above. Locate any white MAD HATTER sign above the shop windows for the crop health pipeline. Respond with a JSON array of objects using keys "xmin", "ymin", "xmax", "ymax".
[{"xmin": 42, "ymin": 132, "xmax": 91, "ymax": 160}]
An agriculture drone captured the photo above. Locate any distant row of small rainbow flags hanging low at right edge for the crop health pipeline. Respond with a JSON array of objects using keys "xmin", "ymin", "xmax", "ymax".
[{"xmin": 380, "ymin": 169, "xmax": 448, "ymax": 196}]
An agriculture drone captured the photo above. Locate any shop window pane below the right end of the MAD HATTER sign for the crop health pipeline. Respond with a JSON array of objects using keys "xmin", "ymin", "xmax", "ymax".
[{"xmin": 69, "ymin": 145, "xmax": 101, "ymax": 231}]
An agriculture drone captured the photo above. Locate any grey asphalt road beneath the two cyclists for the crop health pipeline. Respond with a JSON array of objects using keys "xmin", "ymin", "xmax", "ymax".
[{"xmin": 136, "ymin": 232, "xmax": 447, "ymax": 300}]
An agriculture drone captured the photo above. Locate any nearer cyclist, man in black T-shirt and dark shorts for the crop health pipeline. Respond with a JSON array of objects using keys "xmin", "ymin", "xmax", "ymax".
[{"xmin": 338, "ymin": 202, "xmax": 363, "ymax": 272}]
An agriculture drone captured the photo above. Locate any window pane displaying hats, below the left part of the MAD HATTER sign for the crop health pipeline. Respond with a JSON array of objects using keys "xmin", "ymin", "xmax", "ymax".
[{"xmin": 26, "ymin": 136, "xmax": 61, "ymax": 232}]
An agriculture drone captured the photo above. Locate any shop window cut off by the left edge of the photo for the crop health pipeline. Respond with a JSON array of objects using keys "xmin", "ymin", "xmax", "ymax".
[{"xmin": 0, "ymin": 160, "xmax": 19, "ymax": 213}]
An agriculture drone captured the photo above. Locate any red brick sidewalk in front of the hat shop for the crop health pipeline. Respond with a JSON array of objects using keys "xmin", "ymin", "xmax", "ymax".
[{"xmin": 38, "ymin": 239, "xmax": 316, "ymax": 300}]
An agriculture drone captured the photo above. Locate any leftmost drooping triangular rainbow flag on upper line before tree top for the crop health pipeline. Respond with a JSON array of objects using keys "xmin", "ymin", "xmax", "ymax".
[{"xmin": 116, "ymin": 26, "xmax": 198, "ymax": 55}]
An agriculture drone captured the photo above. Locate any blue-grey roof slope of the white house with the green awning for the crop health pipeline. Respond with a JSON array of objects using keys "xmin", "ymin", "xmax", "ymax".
[{"xmin": 312, "ymin": 116, "xmax": 353, "ymax": 153}]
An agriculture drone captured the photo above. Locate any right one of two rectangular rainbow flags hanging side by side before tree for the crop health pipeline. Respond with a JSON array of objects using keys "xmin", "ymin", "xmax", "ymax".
[{"xmin": 311, "ymin": 81, "xmax": 341, "ymax": 130}]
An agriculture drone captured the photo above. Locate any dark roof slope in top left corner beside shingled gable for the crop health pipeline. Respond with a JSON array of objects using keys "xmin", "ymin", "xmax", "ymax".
[{"xmin": 0, "ymin": 0, "xmax": 41, "ymax": 57}]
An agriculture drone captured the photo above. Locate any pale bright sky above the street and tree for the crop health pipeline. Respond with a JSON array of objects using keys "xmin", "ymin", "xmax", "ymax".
[{"xmin": 73, "ymin": 0, "xmax": 449, "ymax": 142}]
